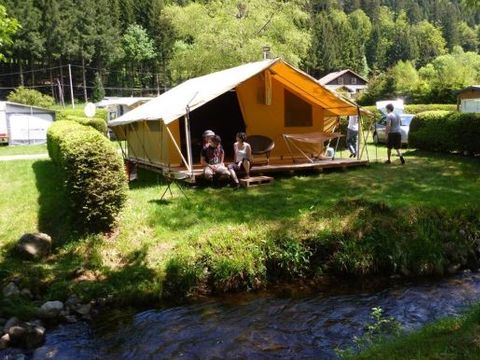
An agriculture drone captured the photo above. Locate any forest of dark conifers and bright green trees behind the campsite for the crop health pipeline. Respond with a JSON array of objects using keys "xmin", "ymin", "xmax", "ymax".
[{"xmin": 0, "ymin": 0, "xmax": 480, "ymax": 102}]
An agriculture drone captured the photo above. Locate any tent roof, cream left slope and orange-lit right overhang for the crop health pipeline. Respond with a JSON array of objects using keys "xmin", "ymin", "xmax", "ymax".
[{"xmin": 109, "ymin": 59, "xmax": 364, "ymax": 127}]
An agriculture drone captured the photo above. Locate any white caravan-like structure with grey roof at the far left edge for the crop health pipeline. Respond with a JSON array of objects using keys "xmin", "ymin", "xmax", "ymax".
[{"xmin": 0, "ymin": 101, "xmax": 55, "ymax": 145}]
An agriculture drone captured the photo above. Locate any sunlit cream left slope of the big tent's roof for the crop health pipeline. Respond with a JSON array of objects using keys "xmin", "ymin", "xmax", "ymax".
[{"xmin": 108, "ymin": 59, "xmax": 279, "ymax": 127}]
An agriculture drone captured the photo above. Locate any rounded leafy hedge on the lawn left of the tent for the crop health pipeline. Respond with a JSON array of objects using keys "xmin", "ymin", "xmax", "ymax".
[{"xmin": 47, "ymin": 121, "xmax": 127, "ymax": 232}]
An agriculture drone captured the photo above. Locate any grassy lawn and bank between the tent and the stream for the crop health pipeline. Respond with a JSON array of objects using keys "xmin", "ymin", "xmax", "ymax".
[{"xmin": 0, "ymin": 152, "xmax": 480, "ymax": 318}]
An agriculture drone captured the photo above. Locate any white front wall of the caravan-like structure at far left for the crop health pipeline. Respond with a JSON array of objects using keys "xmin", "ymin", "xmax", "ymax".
[{"xmin": 8, "ymin": 114, "xmax": 53, "ymax": 145}]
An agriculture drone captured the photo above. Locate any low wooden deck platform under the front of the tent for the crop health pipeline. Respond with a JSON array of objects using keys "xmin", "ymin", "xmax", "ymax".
[{"xmin": 132, "ymin": 158, "xmax": 368, "ymax": 182}]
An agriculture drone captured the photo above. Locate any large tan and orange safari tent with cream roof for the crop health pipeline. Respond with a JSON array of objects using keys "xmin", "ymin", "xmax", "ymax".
[{"xmin": 109, "ymin": 59, "xmax": 366, "ymax": 180}]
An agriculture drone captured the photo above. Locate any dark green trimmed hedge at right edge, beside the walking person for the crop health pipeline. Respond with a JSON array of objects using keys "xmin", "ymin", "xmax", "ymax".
[{"xmin": 408, "ymin": 111, "xmax": 480, "ymax": 154}]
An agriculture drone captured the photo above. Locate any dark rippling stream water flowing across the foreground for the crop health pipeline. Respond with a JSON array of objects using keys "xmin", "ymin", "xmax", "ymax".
[{"xmin": 0, "ymin": 273, "xmax": 480, "ymax": 360}]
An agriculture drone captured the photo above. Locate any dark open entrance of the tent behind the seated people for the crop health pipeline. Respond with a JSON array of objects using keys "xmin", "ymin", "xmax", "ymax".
[{"xmin": 179, "ymin": 91, "xmax": 245, "ymax": 164}]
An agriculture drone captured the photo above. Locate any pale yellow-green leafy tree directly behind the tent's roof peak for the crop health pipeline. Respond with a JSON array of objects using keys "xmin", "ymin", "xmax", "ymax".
[{"xmin": 165, "ymin": 0, "xmax": 310, "ymax": 81}]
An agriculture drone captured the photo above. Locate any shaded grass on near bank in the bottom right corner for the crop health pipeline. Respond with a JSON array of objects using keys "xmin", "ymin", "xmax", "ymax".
[{"xmin": 343, "ymin": 305, "xmax": 480, "ymax": 360}]
